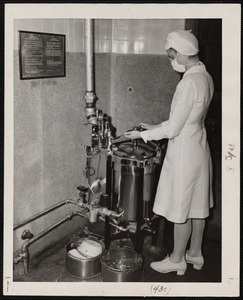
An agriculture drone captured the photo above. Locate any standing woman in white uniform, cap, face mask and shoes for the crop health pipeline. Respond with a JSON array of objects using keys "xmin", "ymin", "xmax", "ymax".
[{"xmin": 125, "ymin": 30, "xmax": 214, "ymax": 275}]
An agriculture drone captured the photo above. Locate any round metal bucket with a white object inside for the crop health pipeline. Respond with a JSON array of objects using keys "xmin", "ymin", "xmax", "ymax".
[{"xmin": 65, "ymin": 237, "xmax": 105, "ymax": 279}]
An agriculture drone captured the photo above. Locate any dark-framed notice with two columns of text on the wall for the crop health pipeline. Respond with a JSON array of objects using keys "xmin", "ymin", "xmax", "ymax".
[{"xmin": 19, "ymin": 31, "xmax": 66, "ymax": 79}]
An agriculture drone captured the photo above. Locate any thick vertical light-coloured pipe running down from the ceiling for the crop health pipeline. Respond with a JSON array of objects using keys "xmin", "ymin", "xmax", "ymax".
[{"xmin": 84, "ymin": 19, "xmax": 97, "ymax": 125}]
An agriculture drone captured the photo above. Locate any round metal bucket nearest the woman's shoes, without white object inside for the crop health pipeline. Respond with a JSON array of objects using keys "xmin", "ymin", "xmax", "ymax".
[{"xmin": 101, "ymin": 247, "xmax": 144, "ymax": 282}]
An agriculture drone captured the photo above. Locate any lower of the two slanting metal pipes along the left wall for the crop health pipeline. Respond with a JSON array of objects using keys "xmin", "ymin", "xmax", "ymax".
[{"xmin": 19, "ymin": 211, "xmax": 85, "ymax": 275}]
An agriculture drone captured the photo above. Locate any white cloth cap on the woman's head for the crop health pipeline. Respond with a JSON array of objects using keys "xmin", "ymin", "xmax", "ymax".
[{"xmin": 165, "ymin": 30, "xmax": 199, "ymax": 56}]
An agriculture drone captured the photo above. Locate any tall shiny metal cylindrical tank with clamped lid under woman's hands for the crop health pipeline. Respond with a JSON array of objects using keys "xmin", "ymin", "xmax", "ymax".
[{"xmin": 110, "ymin": 140, "xmax": 160, "ymax": 222}]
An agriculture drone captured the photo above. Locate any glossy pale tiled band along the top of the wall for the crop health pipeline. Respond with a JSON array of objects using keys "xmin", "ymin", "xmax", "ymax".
[{"xmin": 14, "ymin": 19, "xmax": 185, "ymax": 54}]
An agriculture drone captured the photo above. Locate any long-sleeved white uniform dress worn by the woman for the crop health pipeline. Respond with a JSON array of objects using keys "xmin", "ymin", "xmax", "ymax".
[{"xmin": 141, "ymin": 63, "xmax": 214, "ymax": 223}]
